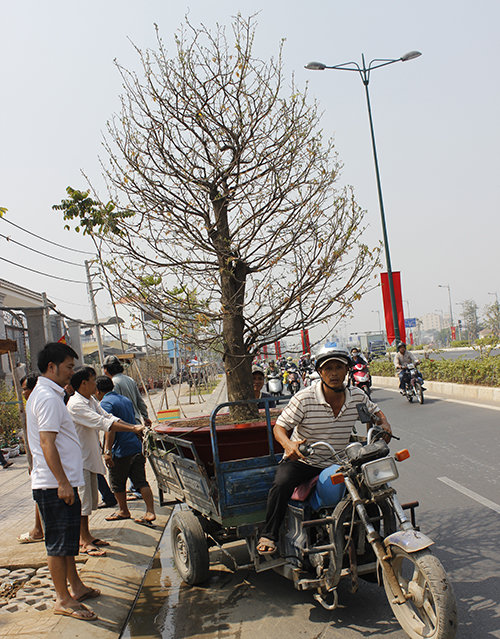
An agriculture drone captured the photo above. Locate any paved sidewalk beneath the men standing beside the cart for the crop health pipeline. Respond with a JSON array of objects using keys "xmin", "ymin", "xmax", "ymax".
[{"xmin": 0, "ymin": 377, "xmax": 226, "ymax": 639}]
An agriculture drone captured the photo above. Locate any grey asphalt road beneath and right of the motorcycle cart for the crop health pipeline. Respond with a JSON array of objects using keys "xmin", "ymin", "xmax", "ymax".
[{"xmin": 123, "ymin": 390, "xmax": 500, "ymax": 639}]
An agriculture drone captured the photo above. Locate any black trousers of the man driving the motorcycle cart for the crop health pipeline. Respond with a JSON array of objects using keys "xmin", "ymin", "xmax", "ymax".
[{"xmin": 261, "ymin": 461, "xmax": 323, "ymax": 541}]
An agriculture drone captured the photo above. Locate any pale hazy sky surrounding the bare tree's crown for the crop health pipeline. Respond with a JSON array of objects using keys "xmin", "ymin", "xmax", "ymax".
[{"xmin": 0, "ymin": 0, "xmax": 500, "ymax": 350}]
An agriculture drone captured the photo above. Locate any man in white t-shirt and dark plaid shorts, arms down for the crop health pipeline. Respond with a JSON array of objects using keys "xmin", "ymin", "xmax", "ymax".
[{"xmin": 26, "ymin": 342, "xmax": 101, "ymax": 621}]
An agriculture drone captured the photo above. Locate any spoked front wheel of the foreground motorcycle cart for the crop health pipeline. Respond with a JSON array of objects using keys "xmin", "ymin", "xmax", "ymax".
[{"xmin": 384, "ymin": 546, "xmax": 457, "ymax": 639}]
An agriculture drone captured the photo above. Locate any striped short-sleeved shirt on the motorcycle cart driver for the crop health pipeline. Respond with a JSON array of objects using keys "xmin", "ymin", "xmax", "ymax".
[{"xmin": 276, "ymin": 382, "xmax": 380, "ymax": 468}]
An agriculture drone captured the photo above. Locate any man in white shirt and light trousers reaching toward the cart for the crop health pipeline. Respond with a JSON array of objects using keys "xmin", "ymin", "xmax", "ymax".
[{"xmin": 68, "ymin": 366, "xmax": 144, "ymax": 557}]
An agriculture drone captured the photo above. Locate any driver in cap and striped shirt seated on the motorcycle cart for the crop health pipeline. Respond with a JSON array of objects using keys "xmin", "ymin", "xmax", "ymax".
[{"xmin": 257, "ymin": 349, "xmax": 391, "ymax": 554}]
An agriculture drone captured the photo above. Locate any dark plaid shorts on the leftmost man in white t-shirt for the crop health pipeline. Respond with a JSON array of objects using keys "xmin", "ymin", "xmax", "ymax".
[{"xmin": 33, "ymin": 488, "xmax": 81, "ymax": 557}]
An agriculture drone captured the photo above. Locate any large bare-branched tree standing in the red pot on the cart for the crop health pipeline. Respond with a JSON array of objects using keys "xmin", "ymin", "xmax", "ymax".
[{"xmin": 54, "ymin": 16, "xmax": 379, "ymax": 420}]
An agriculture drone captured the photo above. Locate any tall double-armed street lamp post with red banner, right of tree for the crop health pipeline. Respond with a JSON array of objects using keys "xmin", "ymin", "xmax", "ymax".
[{"xmin": 305, "ymin": 51, "xmax": 422, "ymax": 343}]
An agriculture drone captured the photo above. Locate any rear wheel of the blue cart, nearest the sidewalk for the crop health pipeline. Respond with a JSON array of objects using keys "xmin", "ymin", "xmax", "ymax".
[{"xmin": 170, "ymin": 510, "xmax": 209, "ymax": 586}]
